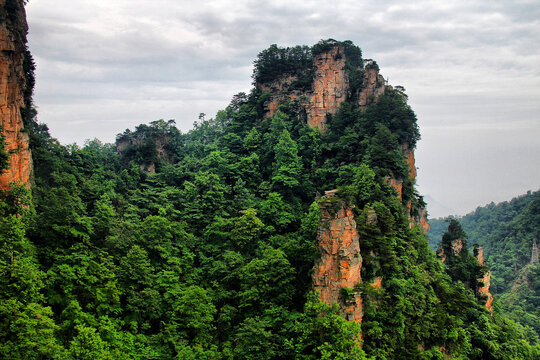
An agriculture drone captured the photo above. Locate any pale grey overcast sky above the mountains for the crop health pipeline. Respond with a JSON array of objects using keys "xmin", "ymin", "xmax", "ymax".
[{"xmin": 26, "ymin": 0, "xmax": 540, "ymax": 217}]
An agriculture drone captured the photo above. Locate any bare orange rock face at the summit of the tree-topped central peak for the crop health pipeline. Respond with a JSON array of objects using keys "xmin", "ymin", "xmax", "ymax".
[{"xmin": 256, "ymin": 45, "xmax": 391, "ymax": 130}]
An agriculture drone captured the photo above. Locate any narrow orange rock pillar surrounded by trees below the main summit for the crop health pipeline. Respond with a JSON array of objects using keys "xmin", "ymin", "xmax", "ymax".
[{"xmin": 313, "ymin": 198, "xmax": 363, "ymax": 322}]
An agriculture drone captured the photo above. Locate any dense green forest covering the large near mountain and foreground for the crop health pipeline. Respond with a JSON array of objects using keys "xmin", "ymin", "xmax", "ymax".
[{"xmin": 0, "ymin": 35, "xmax": 540, "ymax": 360}]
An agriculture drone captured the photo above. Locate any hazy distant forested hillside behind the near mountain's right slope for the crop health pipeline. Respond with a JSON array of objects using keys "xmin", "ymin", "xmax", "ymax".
[{"xmin": 428, "ymin": 191, "xmax": 540, "ymax": 340}]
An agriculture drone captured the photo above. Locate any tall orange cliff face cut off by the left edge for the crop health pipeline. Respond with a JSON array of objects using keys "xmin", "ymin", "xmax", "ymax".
[{"xmin": 0, "ymin": 0, "xmax": 32, "ymax": 189}]
